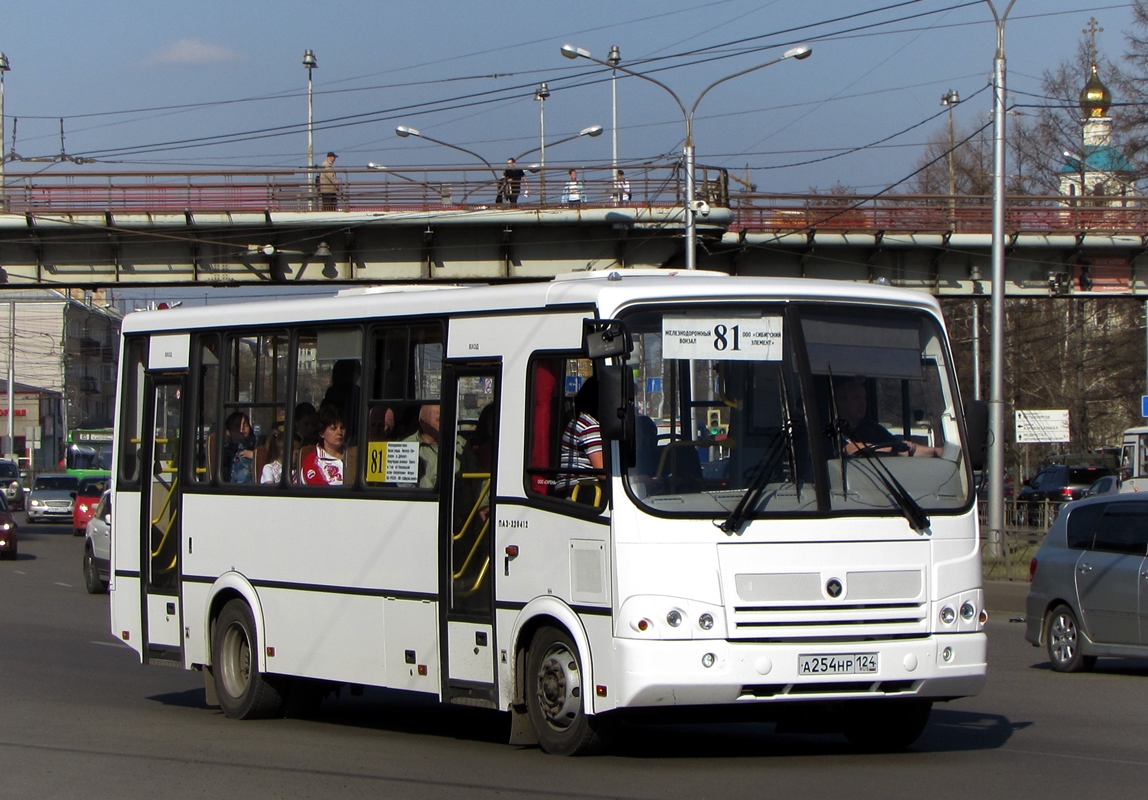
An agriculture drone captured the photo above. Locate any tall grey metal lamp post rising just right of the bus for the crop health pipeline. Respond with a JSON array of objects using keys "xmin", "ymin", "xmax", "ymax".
[{"xmin": 985, "ymin": 0, "xmax": 1016, "ymax": 556}]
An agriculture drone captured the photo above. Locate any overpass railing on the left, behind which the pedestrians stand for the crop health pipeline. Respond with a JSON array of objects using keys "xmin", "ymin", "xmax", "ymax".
[{"xmin": 0, "ymin": 164, "xmax": 729, "ymax": 213}]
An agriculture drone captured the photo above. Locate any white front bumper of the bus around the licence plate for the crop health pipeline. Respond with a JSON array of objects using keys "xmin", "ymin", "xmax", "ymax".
[{"xmin": 596, "ymin": 631, "xmax": 987, "ymax": 710}]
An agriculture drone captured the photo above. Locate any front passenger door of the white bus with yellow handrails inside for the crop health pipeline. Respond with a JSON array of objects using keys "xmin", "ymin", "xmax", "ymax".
[{"xmin": 439, "ymin": 363, "xmax": 501, "ymax": 707}]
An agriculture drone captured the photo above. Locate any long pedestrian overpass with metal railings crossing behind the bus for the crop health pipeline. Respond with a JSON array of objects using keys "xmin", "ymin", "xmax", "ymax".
[{"xmin": 0, "ymin": 164, "xmax": 1148, "ymax": 296}]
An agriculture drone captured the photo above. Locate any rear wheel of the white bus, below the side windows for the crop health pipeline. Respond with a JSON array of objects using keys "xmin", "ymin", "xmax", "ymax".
[{"xmin": 211, "ymin": 599, "xmax": 284, "ymax": 720}]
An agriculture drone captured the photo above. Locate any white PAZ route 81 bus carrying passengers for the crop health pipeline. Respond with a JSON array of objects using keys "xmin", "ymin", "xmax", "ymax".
[{"xmin": 110, "ymin": 271, "xmax": 987, "ymax": 754}]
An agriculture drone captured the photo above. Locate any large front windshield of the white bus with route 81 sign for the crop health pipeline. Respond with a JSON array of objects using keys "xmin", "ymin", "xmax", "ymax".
[{"xmin": 625, "ymin": 303, "xmax": 971, "ymax": 518}]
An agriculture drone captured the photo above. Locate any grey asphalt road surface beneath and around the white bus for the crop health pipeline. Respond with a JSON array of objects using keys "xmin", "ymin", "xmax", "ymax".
[{"xmin": 0, "ymin": 515, "xmax": 1148, "ymax": 800}]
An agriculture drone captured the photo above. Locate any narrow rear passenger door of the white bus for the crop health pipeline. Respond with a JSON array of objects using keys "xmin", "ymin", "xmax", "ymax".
[{"xmin": 140, "ymin": 373, "xmax": 185, "ymax": 666}]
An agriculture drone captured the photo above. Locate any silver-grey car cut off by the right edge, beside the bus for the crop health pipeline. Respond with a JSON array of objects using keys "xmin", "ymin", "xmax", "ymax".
[{"xmin": 1024, "ymin": 494, "xmax": 1148, "ymax": 673}]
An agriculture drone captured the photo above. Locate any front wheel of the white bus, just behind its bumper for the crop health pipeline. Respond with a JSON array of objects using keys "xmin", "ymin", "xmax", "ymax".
[{"xmin": 526, "ymin": 627, "xmax": 600, "ymax": 755}]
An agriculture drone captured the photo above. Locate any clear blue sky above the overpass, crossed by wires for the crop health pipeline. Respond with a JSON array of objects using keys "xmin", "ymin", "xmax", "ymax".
[{"xmin": 0, "ymin": 0, "xmax": 1132, "ymax": 307}]
